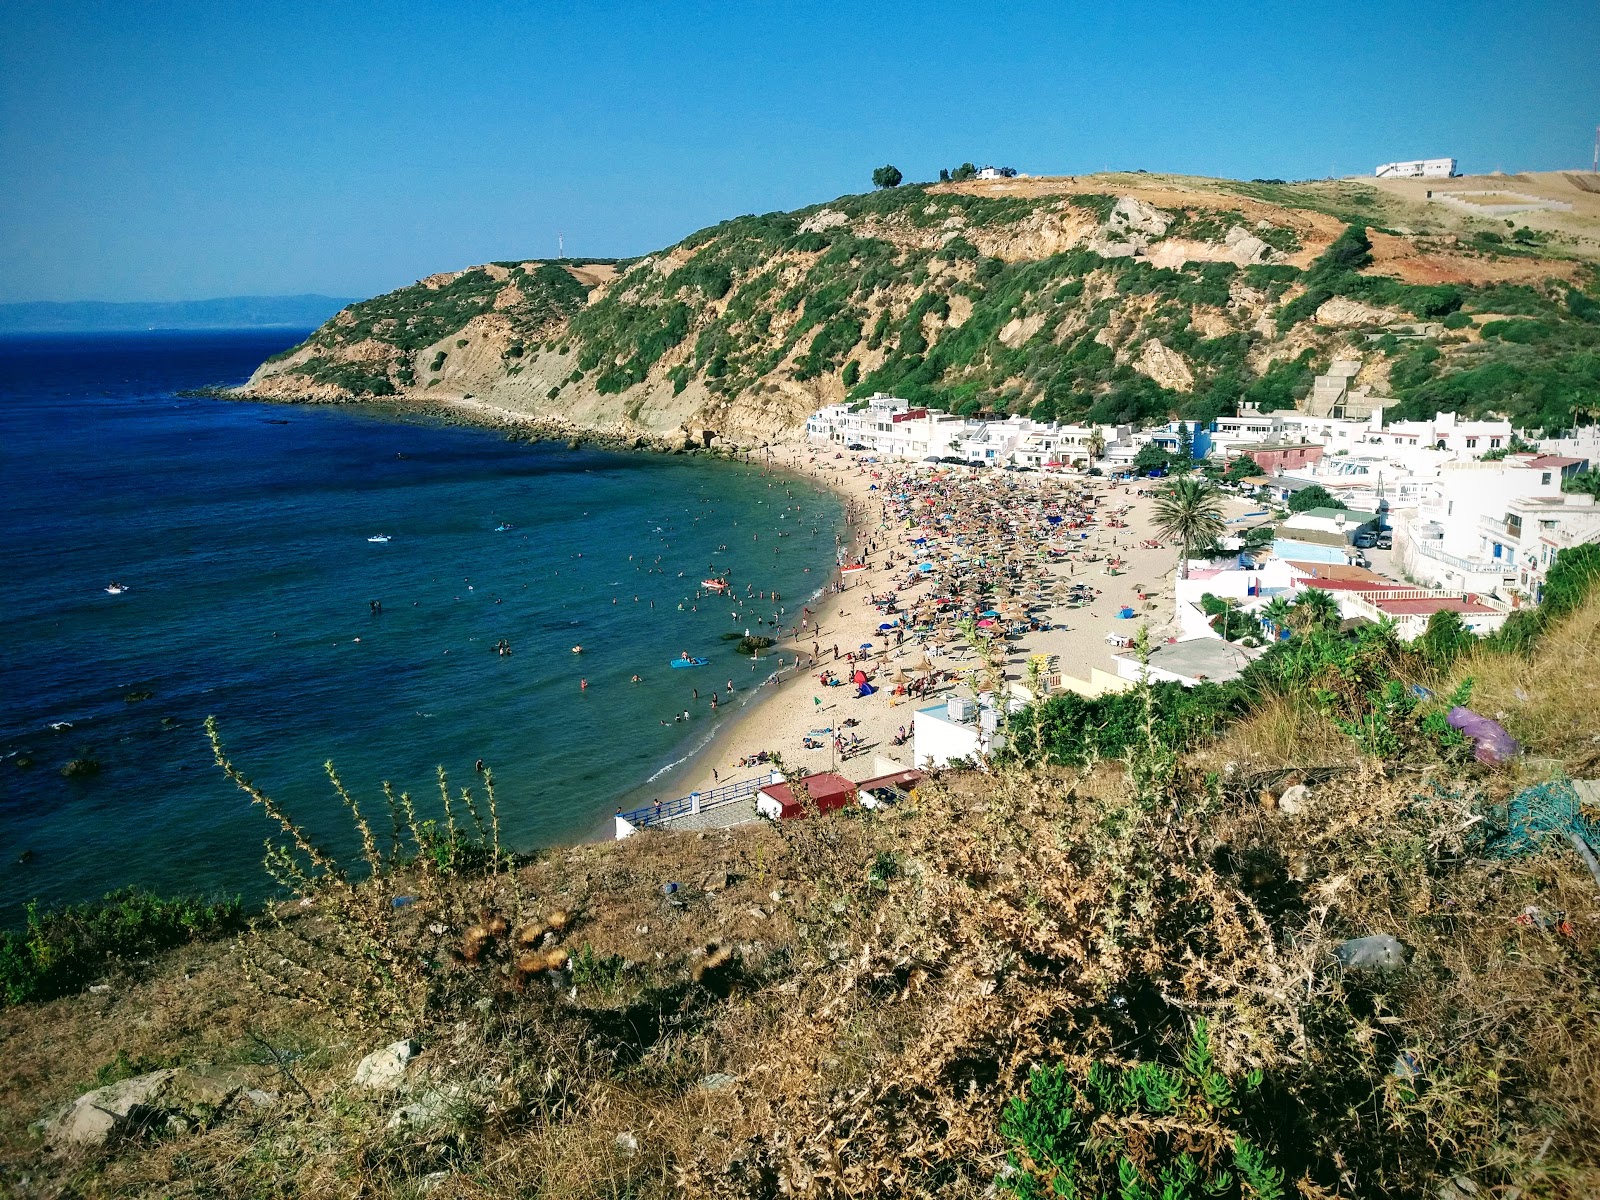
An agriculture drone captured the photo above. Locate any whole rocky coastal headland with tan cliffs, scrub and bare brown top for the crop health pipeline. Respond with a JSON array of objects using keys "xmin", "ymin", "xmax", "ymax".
[{"xmin": 242, "ymin": 173, "xmax": 1600, "ymax": 442}]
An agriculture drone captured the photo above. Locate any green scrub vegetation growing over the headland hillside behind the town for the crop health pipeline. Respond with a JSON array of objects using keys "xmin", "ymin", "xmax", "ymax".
[{"xmin": 256, "ymin": 182, "xmax": 1600, "ymax": 430}]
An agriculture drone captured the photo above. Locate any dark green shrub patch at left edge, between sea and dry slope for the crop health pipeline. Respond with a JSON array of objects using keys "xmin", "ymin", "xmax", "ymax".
[{"xmin": 0, "ymin": 888, "xmax": 243, "ymax": 1005}]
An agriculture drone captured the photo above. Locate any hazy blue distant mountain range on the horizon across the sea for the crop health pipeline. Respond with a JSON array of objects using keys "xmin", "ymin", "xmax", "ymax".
[{"xmin": 0, "ymin": 296, "xmax": 350, "ymax": 333}]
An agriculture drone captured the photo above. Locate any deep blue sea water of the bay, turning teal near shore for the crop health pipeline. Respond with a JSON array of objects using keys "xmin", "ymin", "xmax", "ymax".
[{"xmin": 0, "ymin": 331, "xmax": 842, "ymax": 925}]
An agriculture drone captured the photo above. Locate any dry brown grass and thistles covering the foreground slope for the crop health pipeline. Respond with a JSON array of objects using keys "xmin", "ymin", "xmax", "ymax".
[{"xmin": 9, "ymin": 603, "xmax": 1600, "ymax": 1200}]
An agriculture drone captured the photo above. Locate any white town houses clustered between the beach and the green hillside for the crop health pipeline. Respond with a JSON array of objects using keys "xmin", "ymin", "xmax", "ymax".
[{"xmin": 806, "ymin": 395, "xmax": 1600, "ymax": 643}]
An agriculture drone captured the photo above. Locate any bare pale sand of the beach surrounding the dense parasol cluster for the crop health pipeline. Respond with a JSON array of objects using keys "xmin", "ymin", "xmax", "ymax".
[{"xmin": 665, "ymin": 445, "xmax": 1243, "ymax": 790}]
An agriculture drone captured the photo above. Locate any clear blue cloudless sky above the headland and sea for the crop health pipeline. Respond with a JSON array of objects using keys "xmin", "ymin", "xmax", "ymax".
[{"xmin": 0, "ymin": 0, "xmax": 1600, "ymax": 301}]
